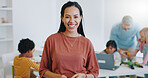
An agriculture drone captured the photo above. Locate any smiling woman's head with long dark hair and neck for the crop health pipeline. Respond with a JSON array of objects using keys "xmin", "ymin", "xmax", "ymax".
[{"xmin": 58, "ymin": 0, "xmax": 85, "ymax": 37}]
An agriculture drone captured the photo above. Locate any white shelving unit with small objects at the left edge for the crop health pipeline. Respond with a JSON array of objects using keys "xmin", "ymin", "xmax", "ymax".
[{"xmin": 0, "ymin": 0, "xmax": 14, "ymax": 57}]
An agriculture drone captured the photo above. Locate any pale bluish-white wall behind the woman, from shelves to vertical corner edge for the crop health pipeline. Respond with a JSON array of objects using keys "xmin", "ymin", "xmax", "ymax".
[{"xmin": 13, "ymin": 0, "xmax": 104, "ymax": 51}]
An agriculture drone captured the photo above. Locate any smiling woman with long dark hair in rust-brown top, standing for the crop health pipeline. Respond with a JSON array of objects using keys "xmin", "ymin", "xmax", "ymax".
[{"xmin": 39, "ymin": 1, "xmax": 99, "ymax": 78}]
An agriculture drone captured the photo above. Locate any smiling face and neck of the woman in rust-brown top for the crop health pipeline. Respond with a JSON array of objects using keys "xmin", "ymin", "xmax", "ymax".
[{"xmin": 61, "ymin": 6, "xmax": 82, "ymax": 32}]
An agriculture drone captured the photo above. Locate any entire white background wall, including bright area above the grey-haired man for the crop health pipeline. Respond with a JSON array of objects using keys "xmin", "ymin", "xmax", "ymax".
[{"xmin": 13, "ymin": 0, "xmax": 148, "ymax": 51}]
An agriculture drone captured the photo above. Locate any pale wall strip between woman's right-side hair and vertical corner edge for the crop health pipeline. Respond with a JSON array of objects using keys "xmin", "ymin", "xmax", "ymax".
[{"xmin": 79, "ymin": 0, "xmax": 105, "ymax": 52}]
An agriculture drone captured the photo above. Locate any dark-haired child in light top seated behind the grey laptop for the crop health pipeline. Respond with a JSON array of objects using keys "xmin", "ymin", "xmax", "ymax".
[{"xmin": 100, "ymin": 40, "xmax": 121, "ymax": 78}]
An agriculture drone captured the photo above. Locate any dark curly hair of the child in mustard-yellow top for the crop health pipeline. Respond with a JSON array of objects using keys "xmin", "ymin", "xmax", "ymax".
[{"xmin": 18, "ymin": 38, "xmax": 35, "ymax": 54}]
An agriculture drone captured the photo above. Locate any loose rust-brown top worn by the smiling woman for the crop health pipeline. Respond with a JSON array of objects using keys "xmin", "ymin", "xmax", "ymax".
[{"xmin": 39, "ymin": 33, "xmax": 99, "ymax": 78}]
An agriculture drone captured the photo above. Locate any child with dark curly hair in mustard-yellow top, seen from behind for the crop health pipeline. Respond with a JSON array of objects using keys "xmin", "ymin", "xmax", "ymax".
[{"xmin": 14, "ymin": 38, "xmax": 39, "ymax": 78}]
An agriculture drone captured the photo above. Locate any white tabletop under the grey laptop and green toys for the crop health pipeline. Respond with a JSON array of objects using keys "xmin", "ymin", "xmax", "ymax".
[{"xmin": 98, "ymin": 64, "xmax": 148, "ymax": 78}]
